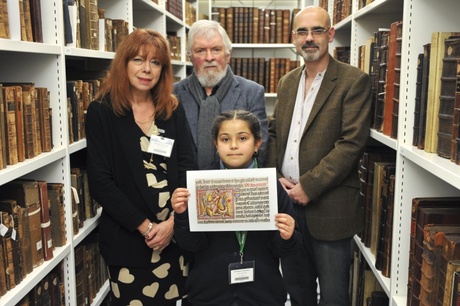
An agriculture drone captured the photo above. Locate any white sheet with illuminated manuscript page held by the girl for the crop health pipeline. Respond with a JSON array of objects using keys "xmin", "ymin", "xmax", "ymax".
[{"xmin": 187, "ymin": 168, "xmax": 277, "ymax": 231}]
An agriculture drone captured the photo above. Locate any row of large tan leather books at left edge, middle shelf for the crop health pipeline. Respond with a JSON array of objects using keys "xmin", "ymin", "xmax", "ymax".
[{"xmin": 0, "ymin": 83, "xmax": 53, "ymax": 169}]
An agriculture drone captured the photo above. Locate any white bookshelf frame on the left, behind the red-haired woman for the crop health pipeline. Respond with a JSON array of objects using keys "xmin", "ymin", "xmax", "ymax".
[{"xmin": 0, "ymin": 0, "xmax": 198, "ymax": 305}]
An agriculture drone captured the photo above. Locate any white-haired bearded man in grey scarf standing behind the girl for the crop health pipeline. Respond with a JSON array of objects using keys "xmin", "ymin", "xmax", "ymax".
[{"xmin": 174, "ymin": 20, "xmax": 268, "ymax": 169}]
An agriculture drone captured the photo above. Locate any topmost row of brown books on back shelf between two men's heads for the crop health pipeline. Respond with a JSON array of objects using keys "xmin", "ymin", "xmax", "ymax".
[{"xmin": 211, "ymin": 6, "xmax": 299, "ymax": 44}]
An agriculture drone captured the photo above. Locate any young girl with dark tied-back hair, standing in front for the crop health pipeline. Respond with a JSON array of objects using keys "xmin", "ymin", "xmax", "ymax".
[{"xmin": 171, "ymin": 110, "xmax": 301, "ymax": 306}]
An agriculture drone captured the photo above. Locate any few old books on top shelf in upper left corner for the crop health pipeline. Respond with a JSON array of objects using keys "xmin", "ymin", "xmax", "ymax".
[{"xmin": 0, "ymin": 0, "xmax": 43, "ymax": 43}]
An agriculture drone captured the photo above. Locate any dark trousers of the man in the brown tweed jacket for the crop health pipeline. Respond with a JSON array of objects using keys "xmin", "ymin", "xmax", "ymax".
[{"xmin": 281, "ymin": 205, "xmax": 351, "ymax": 306}]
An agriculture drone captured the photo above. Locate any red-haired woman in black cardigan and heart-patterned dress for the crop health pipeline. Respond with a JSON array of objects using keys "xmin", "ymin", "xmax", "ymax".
[{"xmin": 86, "ymin": 29, "xmax": 195, "ymax": 305}]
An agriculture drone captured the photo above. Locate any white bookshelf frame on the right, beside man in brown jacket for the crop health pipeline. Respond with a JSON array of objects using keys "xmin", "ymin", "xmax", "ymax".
[{"xmin": 329, "ymin": 0, "xmax": 460, "ymax": 305}]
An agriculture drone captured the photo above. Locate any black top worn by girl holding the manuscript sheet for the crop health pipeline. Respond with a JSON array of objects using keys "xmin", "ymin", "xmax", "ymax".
[{"xmin": 174, "ymin": 166, "xmax": 302, "ymax": 306}]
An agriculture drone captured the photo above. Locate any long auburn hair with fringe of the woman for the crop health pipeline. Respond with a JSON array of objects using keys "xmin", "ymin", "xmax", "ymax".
[{"xmin": 95, "ymin": 29, "xmax": 178, "ymax": 119}]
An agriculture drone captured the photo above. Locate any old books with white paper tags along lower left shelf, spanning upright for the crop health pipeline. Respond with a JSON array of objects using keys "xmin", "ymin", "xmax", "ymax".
[{"xmin": 0, "ymin": 168, "xmax": 98, "ymax": 296}]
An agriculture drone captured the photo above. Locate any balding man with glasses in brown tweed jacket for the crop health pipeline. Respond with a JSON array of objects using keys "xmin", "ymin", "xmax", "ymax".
[{"xmin": 267, "ymin": 6, "xmax": 371, "ymax": 306}]
